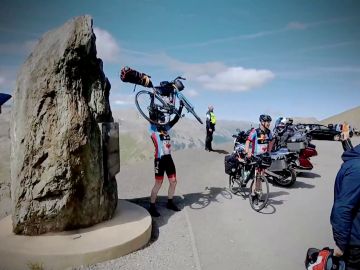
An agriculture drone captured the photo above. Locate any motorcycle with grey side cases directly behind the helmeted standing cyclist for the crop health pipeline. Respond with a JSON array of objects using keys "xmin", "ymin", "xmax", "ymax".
[{"xmin": 232, "ymin": 129, "xmax": 299, "ymax": 187}]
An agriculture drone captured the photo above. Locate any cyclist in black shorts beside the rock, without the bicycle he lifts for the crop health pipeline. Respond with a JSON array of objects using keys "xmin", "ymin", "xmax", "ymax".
[{"xmin": 149, "ymin": 102, "xmax": 184, "ymax": 217}]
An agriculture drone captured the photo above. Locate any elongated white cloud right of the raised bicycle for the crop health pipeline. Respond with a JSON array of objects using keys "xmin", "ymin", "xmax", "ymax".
[{"xmin": 196, "ymin": 67, "xmax": 275, "ymax": 92}]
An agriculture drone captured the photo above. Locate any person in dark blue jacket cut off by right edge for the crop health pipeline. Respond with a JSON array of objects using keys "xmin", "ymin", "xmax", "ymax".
[{"xmin": 330, "ymin": 145, "xmax": 360, "ymax": 270}]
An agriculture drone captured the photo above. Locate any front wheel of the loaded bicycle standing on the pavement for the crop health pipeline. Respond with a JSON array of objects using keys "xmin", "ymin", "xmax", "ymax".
[{"xmin": 249, "ymin": 176, "xmax": 269, "ymax": 212}]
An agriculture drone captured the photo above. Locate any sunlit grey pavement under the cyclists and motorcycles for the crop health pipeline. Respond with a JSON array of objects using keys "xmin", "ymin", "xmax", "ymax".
[{"xmin": 83, "ymin": 138, "xmax": 360, "ymax": 270}]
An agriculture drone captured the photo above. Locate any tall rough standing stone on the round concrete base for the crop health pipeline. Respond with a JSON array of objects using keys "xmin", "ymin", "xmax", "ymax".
[{"xmin": 10, "ymin": 16, "xmax": 117, "ymax": 235}]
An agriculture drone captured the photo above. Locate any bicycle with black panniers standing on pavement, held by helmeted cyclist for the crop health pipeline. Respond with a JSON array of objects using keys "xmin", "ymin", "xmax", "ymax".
[{"xmin": 225, "ymin": 152, "xmax": 271, "ymax": 212}]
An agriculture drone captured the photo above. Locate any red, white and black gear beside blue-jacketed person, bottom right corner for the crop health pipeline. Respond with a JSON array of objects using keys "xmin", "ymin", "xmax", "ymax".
[{"xmin": 305, "ymin": 247, "xmax": 345, "ymax": 270}]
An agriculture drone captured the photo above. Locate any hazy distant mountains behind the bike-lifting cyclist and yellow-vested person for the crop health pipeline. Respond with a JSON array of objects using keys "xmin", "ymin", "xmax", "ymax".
[{"xmin": 113, "ymin": 109, "xmax": 255, "ymax": 163}]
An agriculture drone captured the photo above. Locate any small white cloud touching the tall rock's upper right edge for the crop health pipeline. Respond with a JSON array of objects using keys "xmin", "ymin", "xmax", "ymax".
[{"xmin": 94, "ymin": 27, "xmax": 120, "ymax": 62}]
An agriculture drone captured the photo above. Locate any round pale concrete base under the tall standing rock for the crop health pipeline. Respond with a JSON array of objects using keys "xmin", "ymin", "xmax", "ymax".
[{"xmin": 0, "ymin": 200, "xmax": 151, "ymax": 270}]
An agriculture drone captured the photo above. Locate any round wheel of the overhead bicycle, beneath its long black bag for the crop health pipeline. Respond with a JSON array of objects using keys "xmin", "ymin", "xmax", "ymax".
[{"xmin": 135, "ymin": 90, "xmax": 170, "ymax": 126}]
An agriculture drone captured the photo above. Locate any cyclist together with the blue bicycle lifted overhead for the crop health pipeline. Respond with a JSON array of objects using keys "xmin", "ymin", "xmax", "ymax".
[{"xmin": 121, "ymin": 68, "xmax": 202, "ymax": 217}]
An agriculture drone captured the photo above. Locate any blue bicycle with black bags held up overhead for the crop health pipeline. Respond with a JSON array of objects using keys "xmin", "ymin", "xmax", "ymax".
[{"xmin": 120, "ymin": 67, "xmax": 203, "ymax": 125}]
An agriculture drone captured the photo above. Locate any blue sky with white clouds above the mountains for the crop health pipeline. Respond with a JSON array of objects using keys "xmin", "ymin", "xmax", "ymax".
[{"xmin": 0, "ymin": 0, "xmax": 360, "ymax": 121}]
